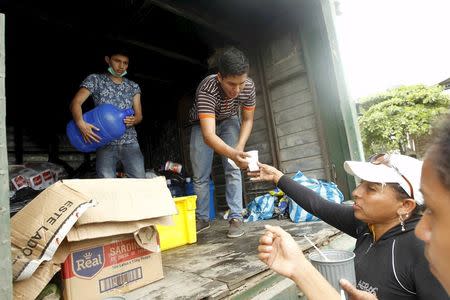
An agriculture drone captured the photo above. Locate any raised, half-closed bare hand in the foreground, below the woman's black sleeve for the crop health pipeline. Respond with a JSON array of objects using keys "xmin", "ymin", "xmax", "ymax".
[{"xmin": 258, "ymin": 225, "xmax": 307, "ymax": 278}]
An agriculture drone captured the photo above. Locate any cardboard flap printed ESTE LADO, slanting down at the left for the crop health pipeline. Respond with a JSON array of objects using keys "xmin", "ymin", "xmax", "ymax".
[{"xmin": 11, "ymin": 182, "xmax": 94, "ymax": 280}]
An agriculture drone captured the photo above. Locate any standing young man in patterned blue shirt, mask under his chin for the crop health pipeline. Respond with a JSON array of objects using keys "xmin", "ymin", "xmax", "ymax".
[{"xmin": 70, "ymin": 48, "xmax": 145, "ymax": 178}]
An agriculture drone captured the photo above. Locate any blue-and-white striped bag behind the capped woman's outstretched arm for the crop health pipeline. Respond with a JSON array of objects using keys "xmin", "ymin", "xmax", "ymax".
[{"xmin": 288, "ymin": 171, "xmax": 344, "ymax": 223}]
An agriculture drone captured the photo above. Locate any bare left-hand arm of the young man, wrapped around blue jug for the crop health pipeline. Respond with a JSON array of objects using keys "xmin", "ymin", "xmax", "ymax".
[{"xmin": 70, "ymin": 87, "xmax": 101, "ymax": 143}]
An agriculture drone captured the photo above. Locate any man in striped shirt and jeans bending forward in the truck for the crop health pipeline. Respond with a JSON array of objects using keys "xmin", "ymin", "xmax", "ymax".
[{"xmin": 190, "ymin": 47, "xmax": 256, "ymax": 238}]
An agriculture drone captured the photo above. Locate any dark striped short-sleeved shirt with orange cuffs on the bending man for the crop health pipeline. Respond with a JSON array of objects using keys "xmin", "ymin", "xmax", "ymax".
[{"xmin": 189, "ymin": 74, "xmax": 256, "ymax": 122}]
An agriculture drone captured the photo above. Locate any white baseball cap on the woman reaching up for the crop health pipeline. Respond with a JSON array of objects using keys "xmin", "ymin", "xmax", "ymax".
[{"xmin": 344, "ymin": 154, "xmax": 423, "ymax": 205}]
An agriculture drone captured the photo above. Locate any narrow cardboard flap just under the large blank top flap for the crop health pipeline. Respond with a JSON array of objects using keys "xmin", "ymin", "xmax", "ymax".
[{"xmin": 67, "ymin": 216, "xmax": 174, "ymax": 242}]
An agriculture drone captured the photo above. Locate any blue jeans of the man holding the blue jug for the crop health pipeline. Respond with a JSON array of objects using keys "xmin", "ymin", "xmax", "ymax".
[{"xmin": 96, "ymin": 143, "xmax": 145, "ymax": 178}]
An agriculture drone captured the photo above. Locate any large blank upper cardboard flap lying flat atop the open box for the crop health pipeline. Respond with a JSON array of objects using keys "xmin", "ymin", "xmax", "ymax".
[{"xmin": 63, "ymin": 177, "xmax": 177, "ymax": 225}]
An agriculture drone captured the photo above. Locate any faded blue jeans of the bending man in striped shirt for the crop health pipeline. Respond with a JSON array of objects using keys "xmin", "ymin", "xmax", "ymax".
[{"xmin": 190, "ymin": 116, "xmax": 242, "ymax": 221}]
